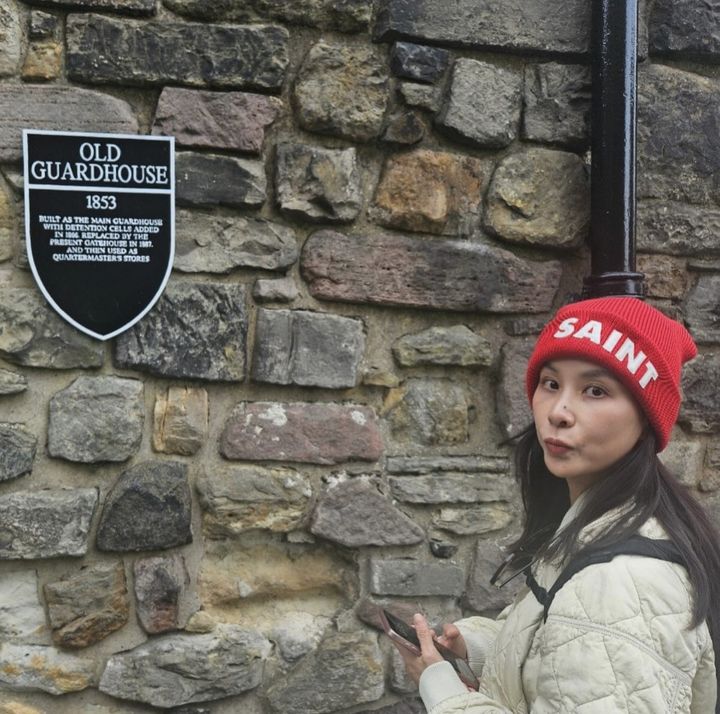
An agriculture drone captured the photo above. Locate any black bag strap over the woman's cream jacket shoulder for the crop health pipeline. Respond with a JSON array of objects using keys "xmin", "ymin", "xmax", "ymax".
[{"xmin": 525, "ymin": 534, "xmax": 685, "ymax": 621}]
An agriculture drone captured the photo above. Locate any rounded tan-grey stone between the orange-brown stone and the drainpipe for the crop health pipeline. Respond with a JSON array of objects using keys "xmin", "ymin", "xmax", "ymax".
[{"xmin": 485, "ymin": 148, "xmax": 590, "ymax": 249}]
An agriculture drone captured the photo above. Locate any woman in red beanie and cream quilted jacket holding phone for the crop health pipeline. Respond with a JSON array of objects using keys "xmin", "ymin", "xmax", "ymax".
[{"xmin": 399, "ymin": 298, "xmax": 720, "ymax": 714}]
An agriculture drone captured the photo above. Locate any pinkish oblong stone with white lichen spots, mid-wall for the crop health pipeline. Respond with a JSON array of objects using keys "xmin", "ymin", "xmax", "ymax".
[{"xmin": 220, "ymin": 402, "xmax": 383, "ymax": 464}]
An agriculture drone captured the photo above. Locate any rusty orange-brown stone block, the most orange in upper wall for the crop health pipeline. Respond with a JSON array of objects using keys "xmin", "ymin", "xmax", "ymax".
[{"xmin": 374, "ymin": 149, "xmax": 490, "ymax": 236}]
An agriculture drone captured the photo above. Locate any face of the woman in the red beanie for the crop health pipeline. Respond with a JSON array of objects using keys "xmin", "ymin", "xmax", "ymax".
[{"xmin": 532, "ymin": 359, "xmax": 645, "ymax": 502}]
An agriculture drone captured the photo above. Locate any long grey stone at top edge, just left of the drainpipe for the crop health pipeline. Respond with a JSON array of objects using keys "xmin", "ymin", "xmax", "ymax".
[{"xmin": 375, "ymin": 0, "xmax": 591, "ymax": 54}]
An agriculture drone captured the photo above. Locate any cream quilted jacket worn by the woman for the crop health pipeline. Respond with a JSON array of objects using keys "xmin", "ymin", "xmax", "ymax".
[{"xmin": 420, "ymin": 499, "xmax": 716, "ymax": 714}]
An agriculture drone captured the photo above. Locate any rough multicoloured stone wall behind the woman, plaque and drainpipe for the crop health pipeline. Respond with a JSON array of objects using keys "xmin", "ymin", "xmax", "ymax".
[{"xmin": 0, "ymin": 0, "xmax": 720, "ymax": 714}]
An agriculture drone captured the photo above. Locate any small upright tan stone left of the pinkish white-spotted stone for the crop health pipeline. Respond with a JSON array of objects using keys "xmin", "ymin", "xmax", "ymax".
[{"xmin": 153, "ymin": 387, "xmax": 208, "ymax": 456}]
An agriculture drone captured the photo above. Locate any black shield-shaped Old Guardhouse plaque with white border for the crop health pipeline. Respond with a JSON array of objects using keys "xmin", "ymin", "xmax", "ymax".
[{"xmin": 23, "ymin": 130, "xmax": 175, "ymax": 340}]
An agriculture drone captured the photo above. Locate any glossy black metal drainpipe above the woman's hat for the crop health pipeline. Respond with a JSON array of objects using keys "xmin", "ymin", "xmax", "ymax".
[{"xmin": 583, "ymin": 0, "xmax": 645, "ymax": 298}]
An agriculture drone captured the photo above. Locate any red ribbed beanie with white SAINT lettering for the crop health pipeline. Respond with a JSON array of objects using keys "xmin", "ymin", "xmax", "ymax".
[{"xmin": 526, "ymin": 297, "xmax": 697, "ymax": 451}]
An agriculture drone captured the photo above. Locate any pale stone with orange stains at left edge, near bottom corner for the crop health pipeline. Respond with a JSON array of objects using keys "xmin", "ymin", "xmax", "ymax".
[{"xmin": 0, "ymin": 642, "xmax": 96, "ymax": 688}]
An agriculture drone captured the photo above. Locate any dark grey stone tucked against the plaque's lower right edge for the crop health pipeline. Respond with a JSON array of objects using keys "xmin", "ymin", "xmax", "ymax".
[{"xmin": 115, "ymin": 283, "xmax": 247, "ymax": 382}]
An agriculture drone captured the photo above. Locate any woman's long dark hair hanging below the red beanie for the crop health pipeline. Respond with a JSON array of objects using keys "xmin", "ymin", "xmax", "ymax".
[{"xmin": 511, "ymin": 426, "xmax": 720, "ymax": 692}]
